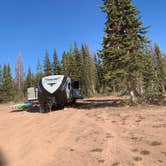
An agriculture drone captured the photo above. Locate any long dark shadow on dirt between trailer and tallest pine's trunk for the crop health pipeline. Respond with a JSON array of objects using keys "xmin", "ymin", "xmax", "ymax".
[{"xmin": 74, "ymin": 99, "xmax": 128, "ymax": 109}]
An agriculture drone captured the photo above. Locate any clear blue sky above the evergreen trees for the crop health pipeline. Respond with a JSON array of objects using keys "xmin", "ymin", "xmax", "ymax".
[{"xmin": 0, "ymin": 0, "xmax": 166, "ymax": 76}]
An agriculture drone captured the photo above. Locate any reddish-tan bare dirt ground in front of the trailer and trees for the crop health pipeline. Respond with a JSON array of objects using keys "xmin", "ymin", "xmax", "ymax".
[{"xmin": 0, "ymin": 97, "xmax": 166, "ymax": 166}]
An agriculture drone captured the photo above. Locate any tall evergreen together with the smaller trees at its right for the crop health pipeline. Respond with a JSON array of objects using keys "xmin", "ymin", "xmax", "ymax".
[{"xmin": 100, "ymin": 0, "xmax": 166, "ymax": 103}]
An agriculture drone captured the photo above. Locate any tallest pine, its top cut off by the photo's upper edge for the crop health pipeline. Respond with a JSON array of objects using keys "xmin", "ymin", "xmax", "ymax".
[{"xmin": 100, "ymin": 0, "xmax": 148, "ymax": 103}]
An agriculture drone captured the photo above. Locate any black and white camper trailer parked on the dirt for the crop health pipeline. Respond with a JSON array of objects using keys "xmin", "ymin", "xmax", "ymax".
[{"xmin": 38, "ymin": 75, "xmax": 82, "ymax": 111}]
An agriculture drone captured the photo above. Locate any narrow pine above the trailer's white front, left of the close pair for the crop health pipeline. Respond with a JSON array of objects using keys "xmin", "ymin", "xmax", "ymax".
[{"xmin": 44, "ymin": 50, "xmax": 52, "ymax": 76}]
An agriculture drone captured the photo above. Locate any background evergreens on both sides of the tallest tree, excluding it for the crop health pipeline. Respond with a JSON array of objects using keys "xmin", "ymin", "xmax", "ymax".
[{"xmin": 0, "ymin": 43, "xmax": 166, "ymax": 103}]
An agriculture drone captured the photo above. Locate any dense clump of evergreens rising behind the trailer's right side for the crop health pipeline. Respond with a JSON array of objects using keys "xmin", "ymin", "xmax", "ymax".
[{"xmin": 62, "ymin": 43, "xmax": 97, "ymax": 96}]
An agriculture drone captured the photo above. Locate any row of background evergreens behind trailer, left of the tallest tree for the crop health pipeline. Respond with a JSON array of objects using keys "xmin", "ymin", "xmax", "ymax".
[{"xmin": 0, "ymin": 43, "xmax": 103, "ymax": 102}]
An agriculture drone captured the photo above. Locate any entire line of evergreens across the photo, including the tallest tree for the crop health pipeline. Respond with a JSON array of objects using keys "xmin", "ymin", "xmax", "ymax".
[{"xmin": 0, "ymin": 0, "xmax": 166, "ymax": 103}]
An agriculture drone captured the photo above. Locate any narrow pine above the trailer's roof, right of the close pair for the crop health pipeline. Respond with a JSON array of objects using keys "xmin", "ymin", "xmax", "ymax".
[{"xmin": 52, "ymin": 50, "xmax": 61, "ymax": 75}]
